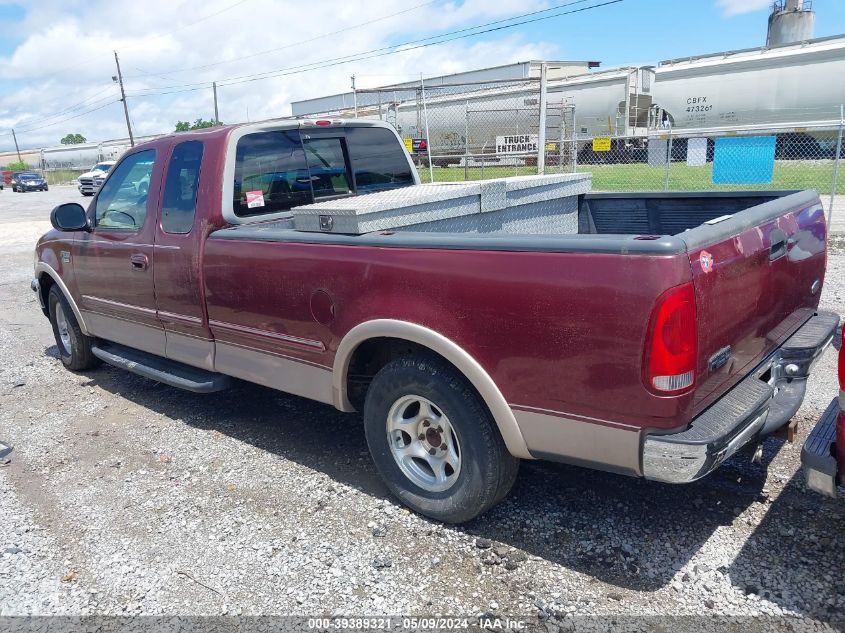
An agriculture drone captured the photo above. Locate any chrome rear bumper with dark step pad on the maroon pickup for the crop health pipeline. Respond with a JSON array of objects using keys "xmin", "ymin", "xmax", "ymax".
[{"xmin": 642, "ymin": 313, "xmax": 839, "ymax": 483}]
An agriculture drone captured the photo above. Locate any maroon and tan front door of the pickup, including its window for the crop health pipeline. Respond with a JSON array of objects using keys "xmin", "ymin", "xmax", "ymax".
[{"xmin": 73, "ymin": 149, "xmax": 164, "ymax": 354}]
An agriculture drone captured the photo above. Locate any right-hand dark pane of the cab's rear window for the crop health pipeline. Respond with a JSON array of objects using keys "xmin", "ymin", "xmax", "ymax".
[{"xmin": 346, "ymin": 127, "xmax": 414, "ymax": 193}]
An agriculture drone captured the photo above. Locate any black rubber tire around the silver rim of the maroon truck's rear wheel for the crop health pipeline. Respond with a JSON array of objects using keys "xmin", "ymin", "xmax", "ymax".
[{"xmin": 364, "ymin": 355, "xmax": 519, "ymax": 523}]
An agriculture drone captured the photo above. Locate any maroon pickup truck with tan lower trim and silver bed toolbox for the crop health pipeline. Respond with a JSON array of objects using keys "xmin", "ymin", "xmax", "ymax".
[{"xmin": 32, "ymin": 120, "xmax": 838, "ymax": 522}]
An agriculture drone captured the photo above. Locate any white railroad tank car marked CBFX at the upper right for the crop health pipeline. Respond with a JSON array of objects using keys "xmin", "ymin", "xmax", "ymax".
[{"xmin": 650, "ymin": 36, "xmax": 845, "ymax": 134}]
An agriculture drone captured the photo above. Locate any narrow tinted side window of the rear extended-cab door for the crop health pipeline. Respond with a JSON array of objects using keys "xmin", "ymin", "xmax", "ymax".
[{"xmin": 161, "ymin": 141, "xmax": 203, "ymax": 233}]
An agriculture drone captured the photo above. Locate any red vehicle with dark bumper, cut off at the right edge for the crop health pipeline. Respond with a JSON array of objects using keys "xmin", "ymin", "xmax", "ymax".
[{"xmin": 801, "ymin": 324, "xmax": 845, "ymax": 497}]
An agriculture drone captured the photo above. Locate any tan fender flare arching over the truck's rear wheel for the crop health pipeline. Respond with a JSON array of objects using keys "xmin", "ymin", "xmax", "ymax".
[{"xmin": 332, "ymin": 319, "xmax": 534, "ymax": 459}]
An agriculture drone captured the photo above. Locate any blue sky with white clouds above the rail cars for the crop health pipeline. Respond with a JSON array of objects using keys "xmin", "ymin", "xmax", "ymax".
[{"xmin": 0, "ymin": 0, "xmax": 845, "ymax": 151}]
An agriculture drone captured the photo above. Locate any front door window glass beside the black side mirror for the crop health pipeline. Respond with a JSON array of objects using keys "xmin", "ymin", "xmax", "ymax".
[{"xmin": 94, "ymin": 149, "xmax": 155, "ymax": 231}]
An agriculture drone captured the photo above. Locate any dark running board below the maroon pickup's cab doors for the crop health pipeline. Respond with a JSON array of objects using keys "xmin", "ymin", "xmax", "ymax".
[{"xmin": 91, "ymin": 343, "xmax": 232, "ymax": 393}]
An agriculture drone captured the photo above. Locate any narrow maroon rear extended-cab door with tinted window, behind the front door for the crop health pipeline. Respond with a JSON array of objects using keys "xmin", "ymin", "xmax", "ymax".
[{"xmin": 153, "ymin": 141, "xmax": 219, "ymax": 369}]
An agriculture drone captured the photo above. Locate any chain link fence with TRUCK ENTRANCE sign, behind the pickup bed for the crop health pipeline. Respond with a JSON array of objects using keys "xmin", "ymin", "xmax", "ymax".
[{"xmin": 350, "ymin": 79, "xmax": 845, "ymax": 227}]
